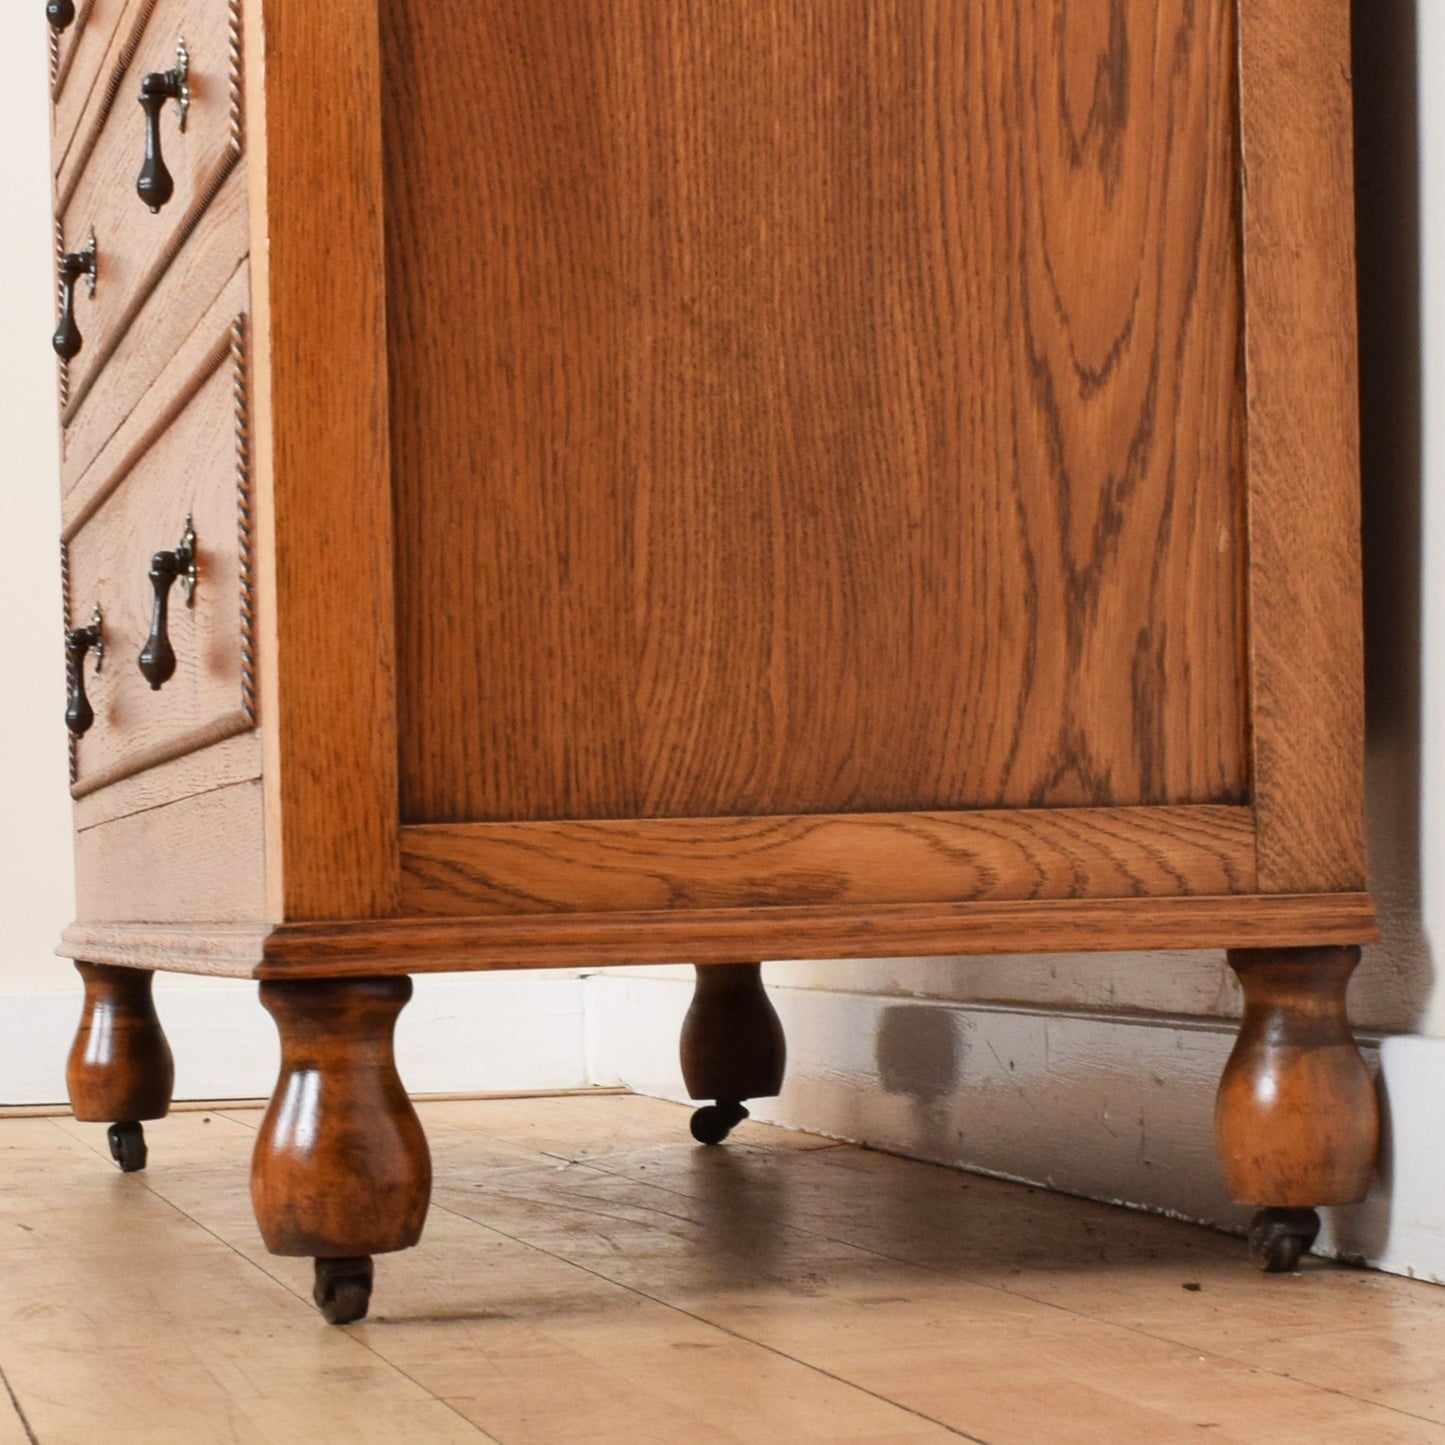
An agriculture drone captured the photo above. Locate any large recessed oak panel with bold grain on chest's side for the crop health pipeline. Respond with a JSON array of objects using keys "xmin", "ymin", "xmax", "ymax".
[{"xmin": 381, "ymin": 0, "xmax": 1248, "ymax": 822}]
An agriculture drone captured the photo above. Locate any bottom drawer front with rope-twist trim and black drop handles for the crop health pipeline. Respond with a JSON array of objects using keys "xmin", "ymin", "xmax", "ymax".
[{"xmin": 65, "ymin": 322, "xmax": 254, "ymax": 798}]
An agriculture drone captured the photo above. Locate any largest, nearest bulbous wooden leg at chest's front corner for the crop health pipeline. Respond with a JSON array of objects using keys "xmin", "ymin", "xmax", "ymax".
[{"xmin": 251, "ymin": 978, "xmax": 432, "ymax": 1324}]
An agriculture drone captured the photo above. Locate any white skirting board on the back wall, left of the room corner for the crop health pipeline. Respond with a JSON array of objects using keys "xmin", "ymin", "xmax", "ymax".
[{"xmin": 0, "ymin": 972, "xmax": 587, "ymax": 1104}]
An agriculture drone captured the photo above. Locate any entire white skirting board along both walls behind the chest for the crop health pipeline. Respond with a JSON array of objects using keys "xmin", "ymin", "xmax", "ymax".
[{"xmin": 0, "ymin": 971, "xmax": 1445, "ymax": 1283}]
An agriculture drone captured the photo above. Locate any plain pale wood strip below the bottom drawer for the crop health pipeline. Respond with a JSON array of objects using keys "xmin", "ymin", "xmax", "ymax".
[{"xmin": 75, "ymin": 782, "xmax": 266, "ymax": 924}]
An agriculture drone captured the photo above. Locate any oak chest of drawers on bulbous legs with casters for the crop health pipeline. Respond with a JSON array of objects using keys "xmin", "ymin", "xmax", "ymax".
[{"xmin": 42, "ymin": 0, "xmax": 1377, "ymax": 1319}]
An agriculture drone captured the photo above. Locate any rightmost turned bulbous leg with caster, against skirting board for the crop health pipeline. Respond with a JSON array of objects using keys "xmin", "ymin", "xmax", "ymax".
[{"xmin": 1214, "ymin": 948, "xmax": 1380, "ymax": 1273}]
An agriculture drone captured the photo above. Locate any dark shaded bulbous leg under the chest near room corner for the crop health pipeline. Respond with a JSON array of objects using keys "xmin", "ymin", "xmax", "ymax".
[{"xmin": 682, "ymin": 964, "xmax": 788, "ymax": 1144}]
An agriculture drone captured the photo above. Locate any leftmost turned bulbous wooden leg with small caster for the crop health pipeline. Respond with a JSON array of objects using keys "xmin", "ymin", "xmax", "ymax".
[{"xmin": 65, "ymin": 962, "xmax": 175, "ymax": 1173}]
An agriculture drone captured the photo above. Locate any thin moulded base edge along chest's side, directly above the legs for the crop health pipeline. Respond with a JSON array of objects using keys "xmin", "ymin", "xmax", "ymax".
[{"xmin": 257, "ymin": 893, "xmax": 1379, "ymax": 978}]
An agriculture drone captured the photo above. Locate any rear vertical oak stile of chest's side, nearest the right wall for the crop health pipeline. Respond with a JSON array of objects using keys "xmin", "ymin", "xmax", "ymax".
[{"xmin": 1240, "ymin": 0, "xmax": 1364, "ymax": 893}]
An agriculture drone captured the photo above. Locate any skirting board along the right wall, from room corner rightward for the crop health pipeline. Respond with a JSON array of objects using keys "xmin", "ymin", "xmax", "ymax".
[{"xmin": 588, "ymin": 974, "xmax": 1445, "ymax": 1282}]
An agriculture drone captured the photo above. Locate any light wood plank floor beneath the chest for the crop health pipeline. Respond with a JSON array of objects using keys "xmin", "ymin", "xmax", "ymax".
[{"xmin": 0, "ymin": 1095, "xmax": 1445, "ymax": 1445}]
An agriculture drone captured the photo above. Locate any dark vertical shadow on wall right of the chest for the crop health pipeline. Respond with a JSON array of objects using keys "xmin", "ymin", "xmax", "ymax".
[{"xmin": 1351, "ymin": 0, "xmax": 1435, "ymax": 1030}]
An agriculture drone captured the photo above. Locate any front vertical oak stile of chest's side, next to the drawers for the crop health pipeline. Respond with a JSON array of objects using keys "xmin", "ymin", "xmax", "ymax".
[{"xmin": 246, "ymin": 0, "xmax": 406, "ymax": 919}]
